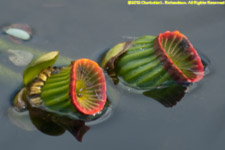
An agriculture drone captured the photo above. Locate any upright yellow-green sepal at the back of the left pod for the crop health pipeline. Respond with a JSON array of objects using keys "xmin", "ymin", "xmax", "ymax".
[{"xmin": 23, "ymin": 51, "xmax": 59, "ymax": 85}]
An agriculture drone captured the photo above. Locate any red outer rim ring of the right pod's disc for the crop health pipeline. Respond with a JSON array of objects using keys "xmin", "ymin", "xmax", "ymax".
[{"xmin": 154, "ymin": 31, "xmax": 204, "ymax": 82}]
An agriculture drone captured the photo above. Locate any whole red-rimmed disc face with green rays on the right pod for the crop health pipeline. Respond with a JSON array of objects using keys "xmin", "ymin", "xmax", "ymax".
[{"xmin": 154, "ymin": 31, "xmax": 204, "ymax": 82}]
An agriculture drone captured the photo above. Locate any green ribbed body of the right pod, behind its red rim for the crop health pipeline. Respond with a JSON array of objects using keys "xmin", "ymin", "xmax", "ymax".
[{"xmin": 116, "ymin": 36, "xmax": 174, "ymax": 90}]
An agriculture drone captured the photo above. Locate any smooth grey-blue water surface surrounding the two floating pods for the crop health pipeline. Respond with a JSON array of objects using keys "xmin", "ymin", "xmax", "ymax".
[{"xmin": 0, "ymin": 0, "xmax": 225, "ymax": 150}]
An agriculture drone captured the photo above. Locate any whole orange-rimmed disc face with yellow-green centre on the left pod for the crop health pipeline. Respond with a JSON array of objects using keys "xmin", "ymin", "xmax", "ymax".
[{"xmin": 70, "ymin": 59, "xmax": 106, "ymax": 115}]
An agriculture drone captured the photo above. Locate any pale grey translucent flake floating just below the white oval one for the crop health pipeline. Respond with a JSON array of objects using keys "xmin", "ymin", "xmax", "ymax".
[{"xmin": 8, "ymin": 49, "xmax": 33, "ymax": 66}]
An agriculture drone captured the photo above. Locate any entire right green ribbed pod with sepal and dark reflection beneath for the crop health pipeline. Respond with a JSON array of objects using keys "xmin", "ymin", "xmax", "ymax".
[{"xmin": 101, "ymin": 31, "xmax": 204, "ymax": 106}]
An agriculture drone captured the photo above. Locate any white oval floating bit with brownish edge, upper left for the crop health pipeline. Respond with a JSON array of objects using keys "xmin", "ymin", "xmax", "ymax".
[{"xmin": 3, "ymin": 24, "xmax": 32, "ymax": 41}]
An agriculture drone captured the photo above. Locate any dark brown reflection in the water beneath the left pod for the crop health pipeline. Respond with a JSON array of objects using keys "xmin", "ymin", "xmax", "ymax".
[{"xmin": 29, "ymin": 108, "xmax": 90, "ymax": 142}]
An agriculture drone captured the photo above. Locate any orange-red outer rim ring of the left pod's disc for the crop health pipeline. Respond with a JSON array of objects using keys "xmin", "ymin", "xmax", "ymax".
[{"xmin": 70, "ymin": 59, "xmax": 107, "ymax": 115}]
